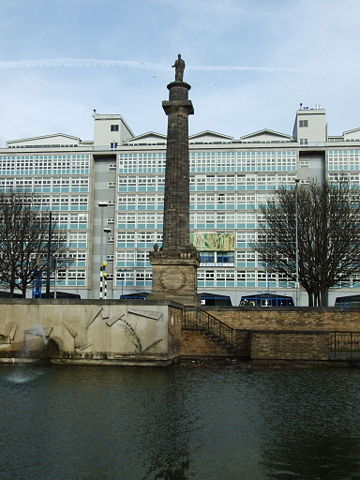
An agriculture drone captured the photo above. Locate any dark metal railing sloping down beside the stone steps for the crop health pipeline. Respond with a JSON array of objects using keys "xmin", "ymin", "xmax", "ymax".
[{"xmin": 183, "ymin": 308, "xmax": 237, "ymax": 349}]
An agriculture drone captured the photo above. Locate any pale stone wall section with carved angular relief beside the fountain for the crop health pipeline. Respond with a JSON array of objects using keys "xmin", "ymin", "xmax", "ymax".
[{"xmin": 0, "ymin": 299, "xmax": 182, "ymax": 364}]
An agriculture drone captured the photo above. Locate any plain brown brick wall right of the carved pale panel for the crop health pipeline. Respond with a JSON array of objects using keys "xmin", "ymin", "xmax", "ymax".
[{"xmin": 181, "ymin": 308, "xmax": 360, "ymax": 361}]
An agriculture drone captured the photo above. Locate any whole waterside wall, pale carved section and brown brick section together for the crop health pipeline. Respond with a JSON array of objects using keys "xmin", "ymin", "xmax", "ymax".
[{"xmin": 0, "ymin": 299, "xmax": 360, "ymax": 365}]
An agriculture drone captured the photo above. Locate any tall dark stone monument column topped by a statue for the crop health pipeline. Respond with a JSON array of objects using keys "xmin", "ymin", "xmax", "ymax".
[{"xmin": 148, "ymin": 55, "xmax": 199, "ymax": 305}]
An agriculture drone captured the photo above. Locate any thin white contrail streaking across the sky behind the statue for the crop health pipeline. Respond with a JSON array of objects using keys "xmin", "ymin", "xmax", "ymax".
[{"xmin": 0, "ymin": 58, "xmax": 306, "ymax": 72}]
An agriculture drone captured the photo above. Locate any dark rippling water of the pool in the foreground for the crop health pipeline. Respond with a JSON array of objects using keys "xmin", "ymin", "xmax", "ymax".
[{"xmin": 0, "ymin": 366, "xmax": 360, "ymax": 480}]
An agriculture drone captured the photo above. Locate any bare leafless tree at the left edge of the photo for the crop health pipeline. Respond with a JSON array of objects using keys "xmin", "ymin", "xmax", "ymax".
[{"xmin": 0, "ymin": 192, "xmax": 63, "ymax": 297}]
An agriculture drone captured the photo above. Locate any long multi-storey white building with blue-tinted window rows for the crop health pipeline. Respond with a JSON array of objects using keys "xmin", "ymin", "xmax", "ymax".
[{"xmin": 0, "ymin": 106, "xmax": 360, "ymax": 305}]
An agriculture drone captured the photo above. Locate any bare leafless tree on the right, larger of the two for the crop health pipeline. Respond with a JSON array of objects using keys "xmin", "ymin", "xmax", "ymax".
[{"xmin": 254, "ymin": 181, "xmax": 360, "ymax": 306}]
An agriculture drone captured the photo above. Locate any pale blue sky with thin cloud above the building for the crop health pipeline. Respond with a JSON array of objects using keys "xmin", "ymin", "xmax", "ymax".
[{"xmin": 0, "ymin": 0, "xmax": 360, "ymax": 146}]
